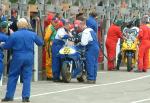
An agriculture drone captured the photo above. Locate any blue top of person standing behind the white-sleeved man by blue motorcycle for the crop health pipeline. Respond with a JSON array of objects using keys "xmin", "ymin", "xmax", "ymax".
[{"xmin": 86, "ymin": 16, "xmax": 98, "ymax": 33}]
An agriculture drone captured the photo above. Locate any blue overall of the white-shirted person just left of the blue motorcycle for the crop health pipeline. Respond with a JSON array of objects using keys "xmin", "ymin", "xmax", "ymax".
[{"xmin": 52, "ymin": 39, "xmax": 65, "ymax": 80}]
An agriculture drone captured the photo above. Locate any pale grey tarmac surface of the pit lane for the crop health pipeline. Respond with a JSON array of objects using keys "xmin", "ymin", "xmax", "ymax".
[{"xmin": 0, "ymin": 69, "xmax": 150, "ymax": 103}]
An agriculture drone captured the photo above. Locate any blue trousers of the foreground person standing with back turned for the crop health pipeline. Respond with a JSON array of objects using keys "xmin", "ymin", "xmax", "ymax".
[{"xmin": 5, "ymin": 52, "xmax": 33, "ymax": 98}]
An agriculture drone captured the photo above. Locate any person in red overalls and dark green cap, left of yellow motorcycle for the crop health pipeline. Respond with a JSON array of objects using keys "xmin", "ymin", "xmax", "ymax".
[{"xmin": 106, "ymin": 19, "xmax": 123, "ymax": 71}]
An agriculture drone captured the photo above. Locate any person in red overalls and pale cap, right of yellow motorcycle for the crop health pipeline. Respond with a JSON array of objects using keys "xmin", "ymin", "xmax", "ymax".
[{"xmin": 135, "ymin": 15, "xmax": 150, "ymax": 72}]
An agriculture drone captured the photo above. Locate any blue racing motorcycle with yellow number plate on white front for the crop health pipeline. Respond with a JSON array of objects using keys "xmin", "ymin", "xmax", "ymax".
[{"xmin": 59, "ymin": 40, "xmax": 86, "ymax": 83}]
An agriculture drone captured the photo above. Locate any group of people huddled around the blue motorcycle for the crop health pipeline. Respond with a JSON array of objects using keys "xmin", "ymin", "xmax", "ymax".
[{"xmin": 41, "ymin": 13, "xmax": 99, "ymax": 83}]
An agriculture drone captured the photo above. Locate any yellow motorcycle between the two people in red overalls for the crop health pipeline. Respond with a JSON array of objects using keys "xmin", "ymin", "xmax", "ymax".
[{"xmin": 117, "ymin": 27, "xmax": 139, "ymax": 72}]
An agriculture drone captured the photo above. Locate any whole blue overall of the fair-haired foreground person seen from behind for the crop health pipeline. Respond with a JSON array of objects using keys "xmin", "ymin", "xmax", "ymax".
[{"xmin": 2, "ymin": 29, "xmax": 43, "ymax": 99}]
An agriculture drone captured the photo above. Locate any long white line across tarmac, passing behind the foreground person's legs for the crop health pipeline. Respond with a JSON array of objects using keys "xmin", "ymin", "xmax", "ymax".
[{"xmin": 15, "ymin": 75, "xmax": 150, "ymax": 99}]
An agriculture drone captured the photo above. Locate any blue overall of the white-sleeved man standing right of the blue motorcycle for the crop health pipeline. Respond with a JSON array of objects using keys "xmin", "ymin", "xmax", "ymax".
[{"xmin": 85, "ymin": 31, "xmax": 99, "ymax": 80}]
